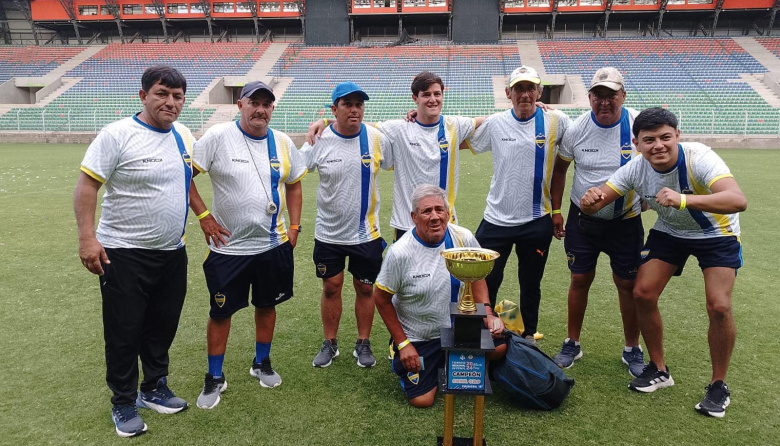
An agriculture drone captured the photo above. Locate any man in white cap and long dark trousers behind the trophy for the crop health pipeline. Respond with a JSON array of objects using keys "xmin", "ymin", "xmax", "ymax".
[{"xmin": 470, "ymin": 66, "xmax": 571, "ymax": 340}]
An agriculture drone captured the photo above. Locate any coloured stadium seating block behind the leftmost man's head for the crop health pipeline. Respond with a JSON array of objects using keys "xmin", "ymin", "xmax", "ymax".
[{"xmin": 0, "ymin": 42, "xmax": 268, "ymax": 131}]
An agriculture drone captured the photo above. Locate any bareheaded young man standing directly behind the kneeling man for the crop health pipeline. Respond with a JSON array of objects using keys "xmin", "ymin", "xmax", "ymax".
[{"xmin": 306, "ymin": 71, "xmax": 484, "ymax": 240}]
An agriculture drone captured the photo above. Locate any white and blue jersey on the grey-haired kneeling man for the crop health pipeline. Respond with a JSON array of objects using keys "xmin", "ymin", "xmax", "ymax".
[{"xmin": 376, "ymin": 223, "xmax": 479, "ymax": 342}]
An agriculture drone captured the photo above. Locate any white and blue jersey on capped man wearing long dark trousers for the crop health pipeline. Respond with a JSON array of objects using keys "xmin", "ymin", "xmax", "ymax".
[{"xmin": 470, "ymin": 108, "xmax": 571, "ymax": 226}]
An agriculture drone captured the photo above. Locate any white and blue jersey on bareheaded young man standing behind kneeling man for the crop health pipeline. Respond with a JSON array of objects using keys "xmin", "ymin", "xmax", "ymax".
[{"xmin": 377, "ymin": 115, "xmax": 476, "ymax": 231}]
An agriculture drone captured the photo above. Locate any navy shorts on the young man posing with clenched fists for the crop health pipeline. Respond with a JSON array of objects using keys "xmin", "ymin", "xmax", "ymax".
[{"xmin": 642, "ymin": 229, "xmax": 742, "ymax": 276}]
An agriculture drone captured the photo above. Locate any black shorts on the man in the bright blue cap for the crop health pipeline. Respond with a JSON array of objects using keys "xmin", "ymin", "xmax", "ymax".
[{"xmin": 312, "ymin": 237, "xmax": 387, "ymax": 285}]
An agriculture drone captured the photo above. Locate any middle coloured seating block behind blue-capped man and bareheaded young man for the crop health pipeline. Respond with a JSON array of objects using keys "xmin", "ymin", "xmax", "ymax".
[{"xmin": 272, "ymin": 44, "xmax": 520, "ymax": 132}]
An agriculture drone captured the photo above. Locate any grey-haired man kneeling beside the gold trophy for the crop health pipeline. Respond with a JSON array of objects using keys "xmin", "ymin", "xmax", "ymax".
[{"xmin": 374, "ymin": 184, "xmax": 506, "ymax": 407}]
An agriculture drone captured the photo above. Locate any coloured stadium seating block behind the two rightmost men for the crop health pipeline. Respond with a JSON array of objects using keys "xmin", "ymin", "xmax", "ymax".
[{"xmin": 538, "ymin": 38, "xmax": 780, "ymax": 134}]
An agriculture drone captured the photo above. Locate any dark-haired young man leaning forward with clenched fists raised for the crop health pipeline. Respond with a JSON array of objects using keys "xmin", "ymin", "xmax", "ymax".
[{"xmin": 580, "ymin": 108, "xmax": 747, "ymax": 418}]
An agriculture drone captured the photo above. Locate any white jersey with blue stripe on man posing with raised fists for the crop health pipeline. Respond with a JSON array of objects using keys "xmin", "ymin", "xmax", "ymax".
[{"xmin": 607, "ymin": 142, "xmax": 739, "ymax": 239}]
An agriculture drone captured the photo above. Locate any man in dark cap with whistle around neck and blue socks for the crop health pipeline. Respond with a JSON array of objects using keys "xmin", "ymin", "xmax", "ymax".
[{"xmin": 190, "ymin": 81, "xmax": 306, "ymax": 409}]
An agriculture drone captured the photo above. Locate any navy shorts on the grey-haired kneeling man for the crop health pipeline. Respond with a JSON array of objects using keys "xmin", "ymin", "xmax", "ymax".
[{"xmin": 390, "ymin": 338, "xmax": 507, "ymax": 399}]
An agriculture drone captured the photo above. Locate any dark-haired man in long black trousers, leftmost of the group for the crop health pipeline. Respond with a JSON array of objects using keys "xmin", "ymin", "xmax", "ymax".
[{"xmin": 73, "ymin": 66, "xmax": 194, "ymax": 437}]
